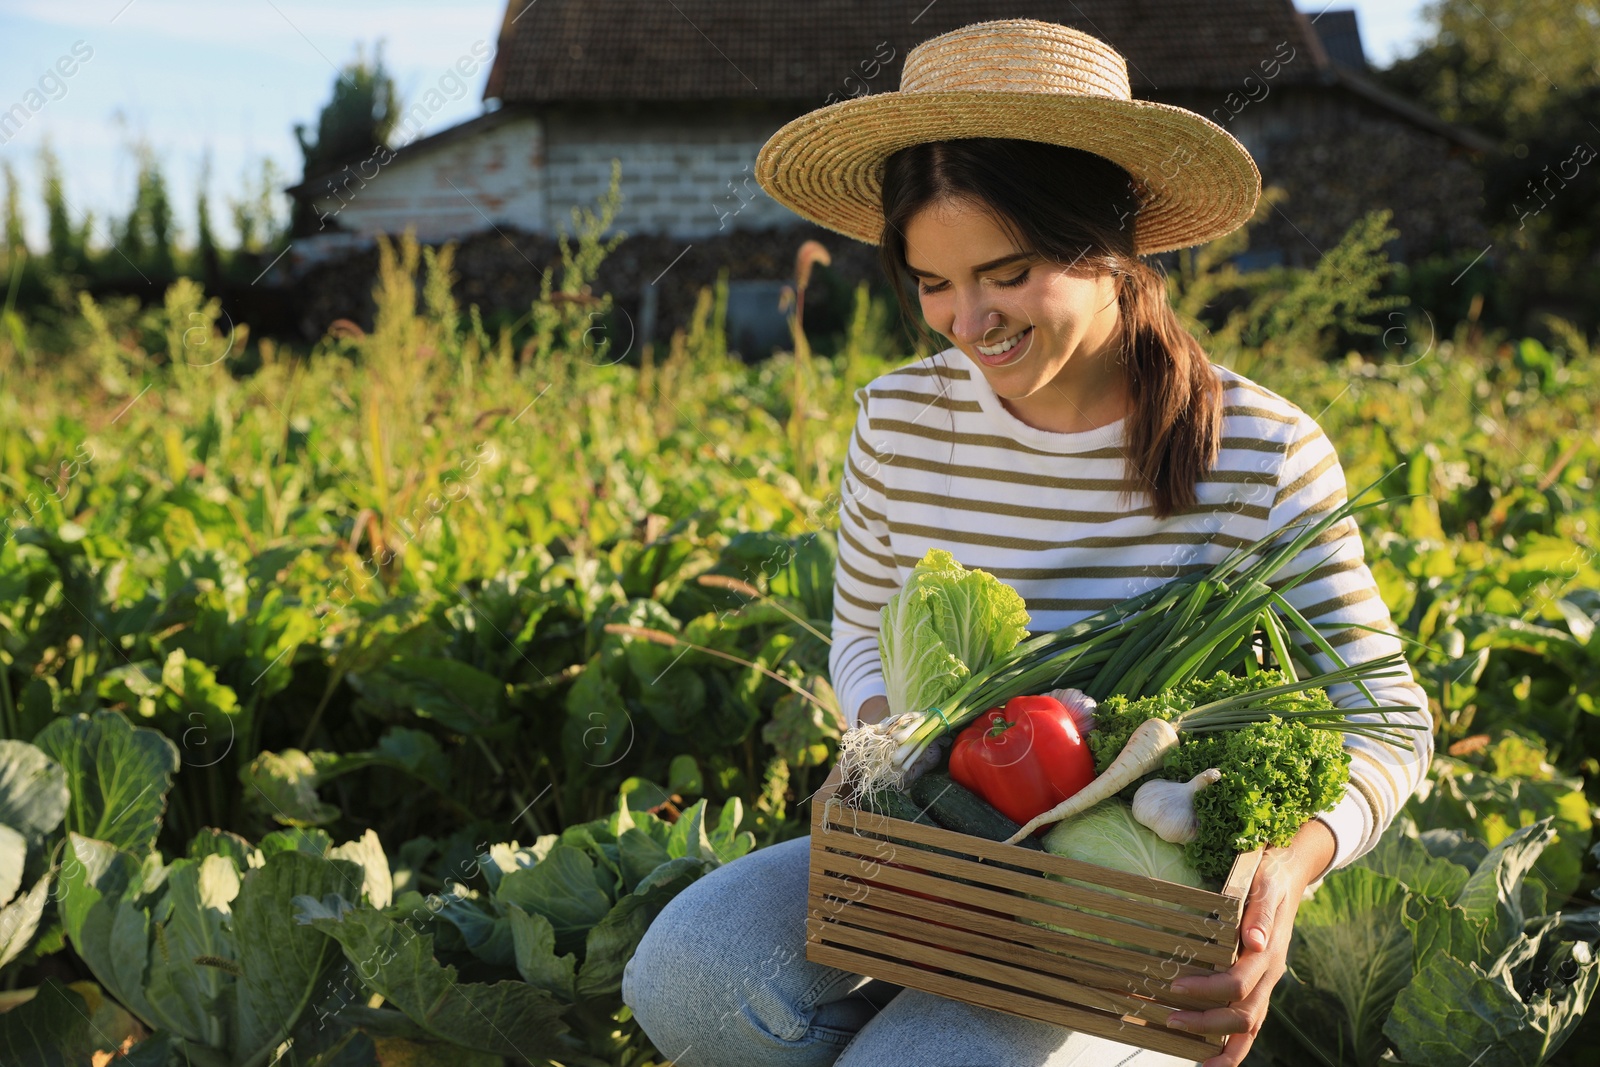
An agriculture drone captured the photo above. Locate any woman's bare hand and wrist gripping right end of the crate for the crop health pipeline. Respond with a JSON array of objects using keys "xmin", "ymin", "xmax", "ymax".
[{"xmin": 1166, "ymin": 819, "xmax": 1334, "ymax": 1067}]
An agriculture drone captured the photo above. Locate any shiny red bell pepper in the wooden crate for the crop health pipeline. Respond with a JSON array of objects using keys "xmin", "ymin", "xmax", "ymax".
[{"xmin": 950, "ymin": 696, "xmax": 1094, "ymax": 822}]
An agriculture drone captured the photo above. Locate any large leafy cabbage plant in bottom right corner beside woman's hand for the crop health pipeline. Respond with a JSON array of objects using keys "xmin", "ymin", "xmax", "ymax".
[{"xmin": 1261, "ymin": 814, "xmax": 1600, "ymax": 1067}]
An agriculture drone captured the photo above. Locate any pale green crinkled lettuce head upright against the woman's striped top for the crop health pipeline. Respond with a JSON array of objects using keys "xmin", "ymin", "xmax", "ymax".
[{"xmin": 878, "ymin": 549, "xmax": 1029, "ymax": 715}]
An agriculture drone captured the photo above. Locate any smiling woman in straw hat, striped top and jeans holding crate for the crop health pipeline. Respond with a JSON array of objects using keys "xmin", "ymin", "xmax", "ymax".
[{"xmin": 622, "ymin": 19, "xmax": 1432, "ymax": 1067}]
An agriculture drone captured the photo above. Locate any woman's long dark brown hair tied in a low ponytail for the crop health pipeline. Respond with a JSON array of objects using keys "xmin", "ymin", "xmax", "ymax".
[{"xmin": 878, "ymin": 138, "xmax": 1222, "ymax": 518}]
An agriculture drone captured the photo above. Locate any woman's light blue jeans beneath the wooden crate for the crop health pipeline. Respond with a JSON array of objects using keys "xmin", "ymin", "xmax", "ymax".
[{"xmin": 622, "ymin": 837, "xmax": 1194, "ymax": 1067}]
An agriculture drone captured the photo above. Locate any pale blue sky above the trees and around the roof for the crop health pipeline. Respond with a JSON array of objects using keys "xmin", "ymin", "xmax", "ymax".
[{"xmin": 0, "ymin": 0, "xmax": 1426, "ymax": 250}]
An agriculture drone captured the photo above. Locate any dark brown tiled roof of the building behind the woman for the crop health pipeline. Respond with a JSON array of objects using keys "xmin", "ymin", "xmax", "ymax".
[{"xmin": 485, "ymin": 0, "xmax": 1330, "ymax": 104}]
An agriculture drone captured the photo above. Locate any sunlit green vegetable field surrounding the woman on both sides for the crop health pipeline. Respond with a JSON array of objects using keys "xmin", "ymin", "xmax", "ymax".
[{"xmin": 0, "ymin": 212, "xmax": 1600, "ymax": 1067}]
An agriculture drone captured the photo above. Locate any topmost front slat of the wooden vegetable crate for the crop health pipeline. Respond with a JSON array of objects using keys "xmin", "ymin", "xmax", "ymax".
[{"xmin": 813, "ymin": 792, "xmax": 1238, "ymax": 912}]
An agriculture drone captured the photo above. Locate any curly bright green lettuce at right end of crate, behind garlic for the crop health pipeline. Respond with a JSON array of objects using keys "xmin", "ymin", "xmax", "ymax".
[{"xmin": 1090, "ymin": 670, "xmax": 1350, "ymax": 878}]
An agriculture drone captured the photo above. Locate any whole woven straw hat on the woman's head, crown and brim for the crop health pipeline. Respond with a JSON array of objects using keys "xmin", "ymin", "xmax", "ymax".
[{"xmin": 755, "ymin": 19, "xmax": 1261, "ymax": 254}]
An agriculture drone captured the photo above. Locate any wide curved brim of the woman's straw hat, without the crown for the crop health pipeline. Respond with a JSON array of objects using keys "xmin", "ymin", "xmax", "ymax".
[{"xmin": 755, "ymin": 90, "xmax": 1261, "ymax": 254}]
